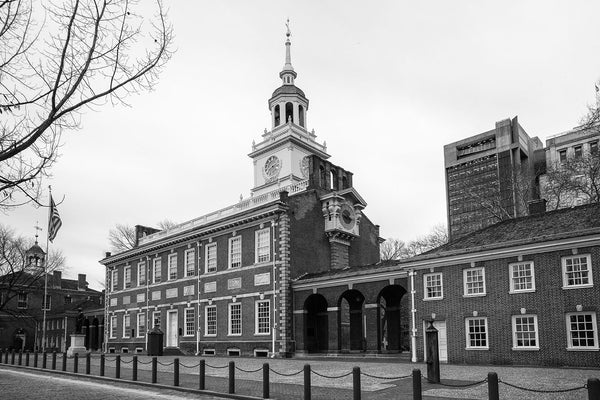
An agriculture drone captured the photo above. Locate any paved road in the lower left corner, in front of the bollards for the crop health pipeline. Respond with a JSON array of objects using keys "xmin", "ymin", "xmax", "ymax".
[{"xmin": 0, "ymin": 368, "xmax": 218, "ymax": 400}]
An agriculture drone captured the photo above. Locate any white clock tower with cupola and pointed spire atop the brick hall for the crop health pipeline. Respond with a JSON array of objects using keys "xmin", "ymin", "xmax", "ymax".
[{"xmin": 248, "ymin": 20, "xmax": 329, "ymax": 196}]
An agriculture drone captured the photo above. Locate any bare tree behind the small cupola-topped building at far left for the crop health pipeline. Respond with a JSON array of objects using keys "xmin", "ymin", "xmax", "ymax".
[{"xmin": 0, "ymin": 225, "xmax": 65, "ymax": 314}]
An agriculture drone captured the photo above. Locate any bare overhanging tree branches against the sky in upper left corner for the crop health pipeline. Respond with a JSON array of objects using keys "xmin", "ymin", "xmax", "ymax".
[{"xmin": 0, "ymin": 0, "xmax": 173, "ymax": 210}]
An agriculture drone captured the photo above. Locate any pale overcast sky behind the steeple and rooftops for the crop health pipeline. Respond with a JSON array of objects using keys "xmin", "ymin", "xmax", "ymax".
[{"xmin": 0, "ymin": 0, "xmax": 600, "ymax": 289}]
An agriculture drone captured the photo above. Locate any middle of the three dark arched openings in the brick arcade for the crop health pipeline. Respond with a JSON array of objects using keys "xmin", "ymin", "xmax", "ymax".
[{"xmin": 338, "ymin": 289, "xmax": 365, "ymax": 351}]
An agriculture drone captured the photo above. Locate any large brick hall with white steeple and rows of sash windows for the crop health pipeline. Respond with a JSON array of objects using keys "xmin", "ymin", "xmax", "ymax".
[{"xmin": 101, "ymin": 30, "xmax": 380, "ymax": 356}]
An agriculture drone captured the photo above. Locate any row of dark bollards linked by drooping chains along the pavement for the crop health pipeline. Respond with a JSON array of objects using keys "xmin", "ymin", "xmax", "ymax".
[{"xmin": 0, "ymin": 350, "xmax": 600, "ymax": 400}]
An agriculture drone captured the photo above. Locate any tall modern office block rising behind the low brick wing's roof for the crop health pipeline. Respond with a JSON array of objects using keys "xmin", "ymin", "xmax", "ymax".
[{"xmin": 444, "ymin": 117, "xmax": 542, "ymax": 239}]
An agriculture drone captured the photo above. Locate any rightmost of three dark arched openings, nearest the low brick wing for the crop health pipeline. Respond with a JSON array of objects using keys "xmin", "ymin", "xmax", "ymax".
[{"xmin": 377, "ymin": 285, "xmax": 408, "ymax": 353}]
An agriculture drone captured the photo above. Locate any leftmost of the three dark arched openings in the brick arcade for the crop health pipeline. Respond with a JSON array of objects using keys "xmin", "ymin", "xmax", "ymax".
[{"xmin": 304, "ymin": 294, "xmax": 329, "ymax": 353}]
